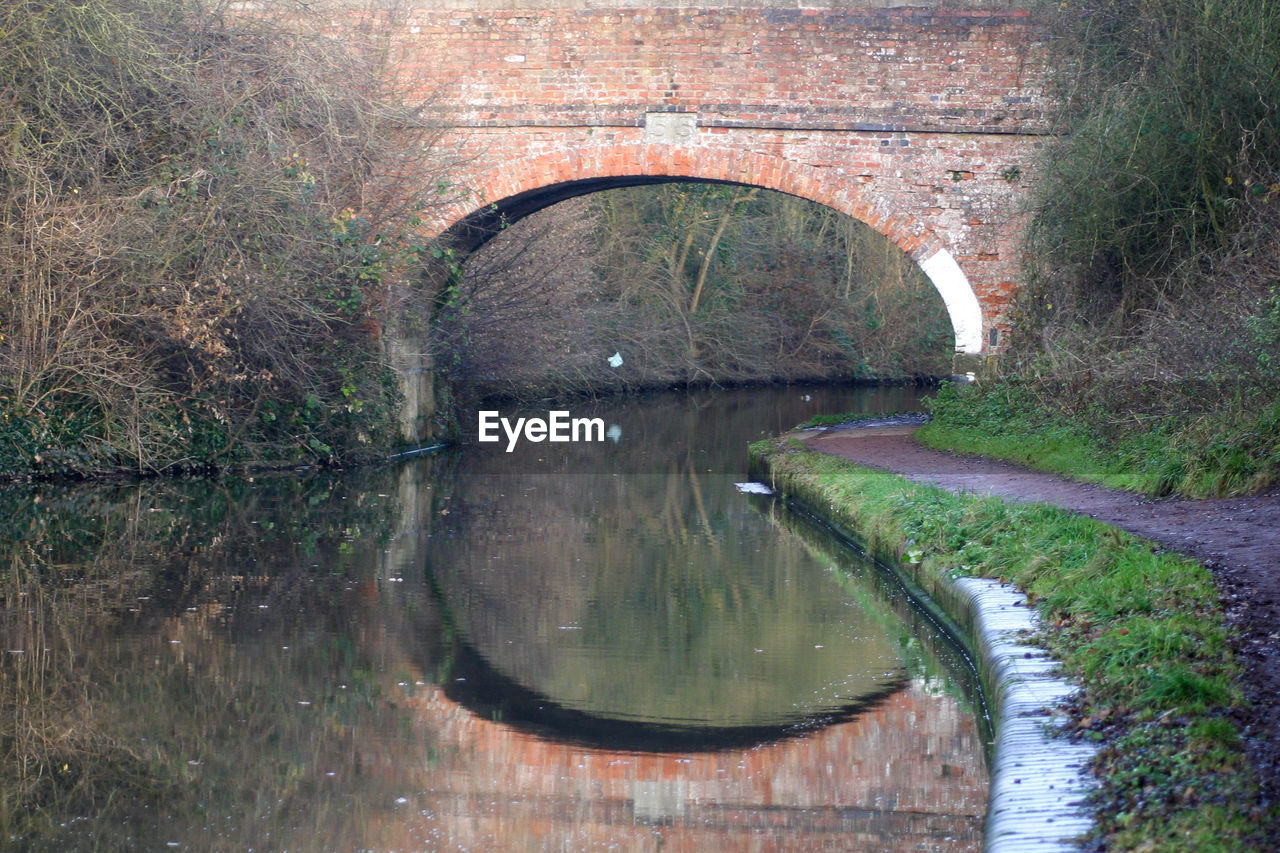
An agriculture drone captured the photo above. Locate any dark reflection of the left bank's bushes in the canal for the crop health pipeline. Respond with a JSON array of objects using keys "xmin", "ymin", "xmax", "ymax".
[{"xmin": 0, "ymin": 474, "xmax": 412, "ymax": 849}]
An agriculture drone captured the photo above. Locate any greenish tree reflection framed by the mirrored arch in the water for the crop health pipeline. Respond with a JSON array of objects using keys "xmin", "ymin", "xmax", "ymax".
[{"xmin": 428, "ymin": 450, "xmax": 902, "ymax": 727}]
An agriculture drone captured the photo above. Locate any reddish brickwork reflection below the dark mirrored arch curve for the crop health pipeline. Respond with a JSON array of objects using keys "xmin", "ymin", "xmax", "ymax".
[{"xmin": 361, "ymin": 683, "xmax": 987, "ymax": 850}]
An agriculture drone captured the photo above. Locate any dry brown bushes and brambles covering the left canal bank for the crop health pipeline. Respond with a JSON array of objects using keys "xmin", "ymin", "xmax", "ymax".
[{"xmin": 0, "ymin": 0, "xmax": 455, "ymax": 475}]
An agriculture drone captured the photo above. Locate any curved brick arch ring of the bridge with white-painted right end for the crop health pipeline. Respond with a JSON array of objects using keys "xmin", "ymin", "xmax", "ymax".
[{"xmin": 424, "ymin": 142, "xmax": 986, "ymax": 355}]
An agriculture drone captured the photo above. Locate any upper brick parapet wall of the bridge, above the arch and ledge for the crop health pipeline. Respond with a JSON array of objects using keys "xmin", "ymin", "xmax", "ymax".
[{"xmin": 398, "ymin": 8, "xmax": 1044, "ymax": 132}]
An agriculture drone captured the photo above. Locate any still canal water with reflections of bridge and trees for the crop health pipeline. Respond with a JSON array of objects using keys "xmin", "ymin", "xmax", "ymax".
[{"xmin": 0, "ymin": 386, "xmax": 988, "ymax": 850}]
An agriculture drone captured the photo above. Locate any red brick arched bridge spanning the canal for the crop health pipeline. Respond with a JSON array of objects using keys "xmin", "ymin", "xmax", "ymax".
[{"xmin": 322, "ymin": 0, "xmax": 1048, "ymax": 432}]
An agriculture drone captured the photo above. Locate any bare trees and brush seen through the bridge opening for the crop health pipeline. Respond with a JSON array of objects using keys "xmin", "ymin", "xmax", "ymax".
[{"xmin": 442, "ymin": 183, "xmax": 951, "ymax": 396}]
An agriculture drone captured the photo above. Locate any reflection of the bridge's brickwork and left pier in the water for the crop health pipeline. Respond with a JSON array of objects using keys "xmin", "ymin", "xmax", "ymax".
[{"xmin": 352, "ymin": 466, "xmax": 988, "ymax": 853}]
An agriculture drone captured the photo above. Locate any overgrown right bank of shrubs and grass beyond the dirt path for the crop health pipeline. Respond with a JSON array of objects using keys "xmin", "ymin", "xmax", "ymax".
[{"xmin": 941, "ymin": 0, "xmax": 1280, "ymax": 496}]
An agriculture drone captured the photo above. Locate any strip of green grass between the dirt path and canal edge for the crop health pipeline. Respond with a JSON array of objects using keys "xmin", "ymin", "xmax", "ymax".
[{"xmin": 751, "ymin": 439, "xmax": 1277, "ymax": 853}]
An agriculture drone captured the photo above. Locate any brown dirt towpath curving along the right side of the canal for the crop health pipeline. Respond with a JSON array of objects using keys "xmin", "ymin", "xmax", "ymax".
[{"xmin": 805, "ymin": 425, "xmax": 1280, "ymax": 802}]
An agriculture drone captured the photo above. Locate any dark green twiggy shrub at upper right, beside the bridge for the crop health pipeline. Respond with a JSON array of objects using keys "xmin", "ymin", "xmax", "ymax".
[{"xmin": 1032, "ymin": 0, "xmax": 1280, "ymax": 308}]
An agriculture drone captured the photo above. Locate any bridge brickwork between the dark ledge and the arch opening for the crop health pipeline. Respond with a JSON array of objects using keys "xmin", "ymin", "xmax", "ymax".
[{"xmin": 442, "ymin": 129, "xmax": 1039, "ymax": 339}]
